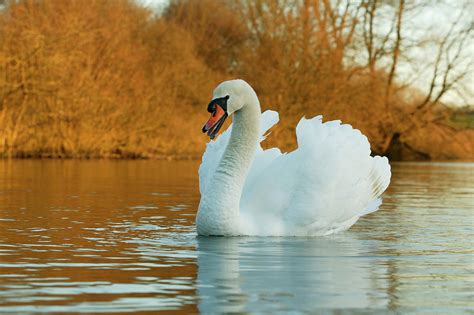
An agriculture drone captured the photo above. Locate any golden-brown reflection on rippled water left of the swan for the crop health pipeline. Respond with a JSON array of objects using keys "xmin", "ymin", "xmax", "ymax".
[{"xmin": 0, "ymin": 160, "xmax": 199, "ymax": 312}]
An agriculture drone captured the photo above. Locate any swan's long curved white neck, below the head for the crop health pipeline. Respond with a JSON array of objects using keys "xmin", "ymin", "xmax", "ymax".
[{"xmin": 197, "ymin": 95, "xmax": 261, "ymax": 235}]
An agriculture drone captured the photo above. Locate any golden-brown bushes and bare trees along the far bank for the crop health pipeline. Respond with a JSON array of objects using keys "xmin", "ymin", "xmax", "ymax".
[{"xmin": 0, "ymin": 0, "xmax": 474, "ymax": 159}]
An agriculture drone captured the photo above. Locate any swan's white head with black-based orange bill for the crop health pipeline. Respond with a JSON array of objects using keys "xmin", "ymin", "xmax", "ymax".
[{"xmin": 202, "ymin": 80, "xmax": 255, "ymax": 139}]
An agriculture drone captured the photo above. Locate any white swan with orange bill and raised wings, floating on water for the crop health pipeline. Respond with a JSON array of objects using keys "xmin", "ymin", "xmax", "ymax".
[{"xmin": 196, "ymin": 80, "xmax": 391, "ymax": 236}]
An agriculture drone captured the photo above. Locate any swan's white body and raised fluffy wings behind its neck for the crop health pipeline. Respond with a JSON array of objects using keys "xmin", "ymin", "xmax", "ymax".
[{"xmin": 241, "ymin": 116, "xmax": 390, "ymax": 235}]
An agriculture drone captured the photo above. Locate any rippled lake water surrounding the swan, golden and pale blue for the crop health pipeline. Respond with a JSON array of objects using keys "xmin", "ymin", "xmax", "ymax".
[{"xmin": 0, "ymin": 160, "xmax": 474, "ymax": 314}]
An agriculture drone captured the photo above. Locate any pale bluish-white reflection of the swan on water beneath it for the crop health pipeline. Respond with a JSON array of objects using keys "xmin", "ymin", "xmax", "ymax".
[{"xmin": 197, "ymin": 233, "xmax": 389, "ymax": 314}]
